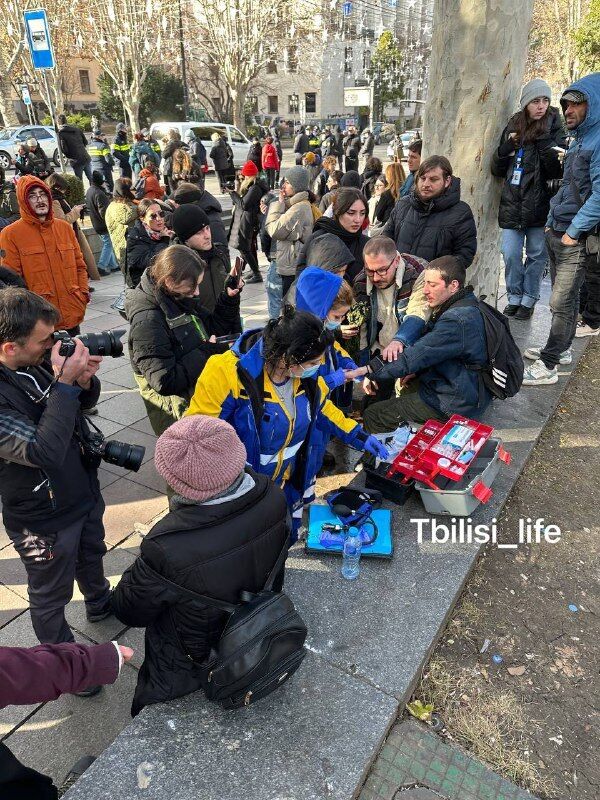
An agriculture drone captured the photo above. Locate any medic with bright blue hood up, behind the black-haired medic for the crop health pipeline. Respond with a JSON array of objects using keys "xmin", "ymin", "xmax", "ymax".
[{"xmin": 296, "ymin": 268, "xmax": 367, "ymax": 485}]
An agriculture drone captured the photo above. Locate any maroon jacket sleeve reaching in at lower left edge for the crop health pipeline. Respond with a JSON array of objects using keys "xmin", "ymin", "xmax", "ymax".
[{"xmin": 0, "ymin": 642, "xmax": 119, "ymax": 708}]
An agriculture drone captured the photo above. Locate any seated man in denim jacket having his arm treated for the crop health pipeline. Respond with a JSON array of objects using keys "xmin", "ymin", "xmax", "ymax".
[{"xmin": 364, "ymin": 256, "xmax": 491, "ymax": 433}]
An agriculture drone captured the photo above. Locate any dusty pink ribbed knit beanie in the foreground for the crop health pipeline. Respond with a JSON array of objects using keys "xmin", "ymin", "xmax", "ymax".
[{"xmin": 154, "ymin": 414, "xmax": 246, "ymax": 502}]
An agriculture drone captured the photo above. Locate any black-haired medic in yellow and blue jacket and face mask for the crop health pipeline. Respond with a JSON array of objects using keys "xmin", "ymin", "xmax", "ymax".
[{"xmin": 185, "ymin": 306, "xmax": 387, "ymax": 535}]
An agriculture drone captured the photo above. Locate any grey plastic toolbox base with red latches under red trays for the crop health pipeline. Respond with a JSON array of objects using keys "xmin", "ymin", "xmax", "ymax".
[{"xmin": 415, "ymin": 438, "xmax": 507, "ymax": 517}]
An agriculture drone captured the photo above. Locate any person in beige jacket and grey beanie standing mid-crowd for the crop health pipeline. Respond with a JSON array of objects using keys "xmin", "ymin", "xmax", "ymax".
[{"xmin": 266, "ymin": 167, "xmax": 313, "ymax": 297}]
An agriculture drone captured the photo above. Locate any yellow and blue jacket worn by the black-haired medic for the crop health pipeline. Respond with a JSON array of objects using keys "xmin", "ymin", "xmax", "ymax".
[{"xmin": 185, "ymin": 330, "xmax": 367, "ymax": 508}]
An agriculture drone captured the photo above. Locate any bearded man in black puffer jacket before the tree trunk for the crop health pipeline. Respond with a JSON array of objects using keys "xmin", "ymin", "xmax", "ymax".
[{"xmin": 382, "ymin": 156, "xmax": 477, "ymax": 269}]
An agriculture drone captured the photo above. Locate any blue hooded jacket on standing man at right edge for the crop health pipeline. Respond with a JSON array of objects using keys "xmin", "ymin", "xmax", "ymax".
[{"xmin": 547, "ymin": 72, "xmax": 600, "ymax": 239}]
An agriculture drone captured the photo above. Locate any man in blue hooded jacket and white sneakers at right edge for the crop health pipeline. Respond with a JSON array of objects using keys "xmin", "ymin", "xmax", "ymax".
[{"xmin": 523, "ymin": 72, "xmax": 600, "ymax": 386}]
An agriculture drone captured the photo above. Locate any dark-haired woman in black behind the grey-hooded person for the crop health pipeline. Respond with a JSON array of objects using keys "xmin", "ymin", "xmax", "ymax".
[{"xmin": 296, "ymin": 187, "xmax": 369, "ymax": 285}]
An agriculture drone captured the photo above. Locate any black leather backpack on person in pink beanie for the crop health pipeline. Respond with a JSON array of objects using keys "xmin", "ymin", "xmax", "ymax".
[{"xmin": 146, "ymin": 542, "xmax": 308, "ymax": 709}]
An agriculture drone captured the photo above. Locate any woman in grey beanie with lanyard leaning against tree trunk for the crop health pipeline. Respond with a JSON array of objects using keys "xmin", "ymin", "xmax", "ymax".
[{"xmin": 492, "ymin": 78, "xmax": 566, "ymax": 319}]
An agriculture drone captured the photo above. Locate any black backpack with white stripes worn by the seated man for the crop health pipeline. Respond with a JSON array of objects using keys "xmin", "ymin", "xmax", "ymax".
[{"xmin": 456, "ymin": 300, "xmax": 525, "ymax": 400}]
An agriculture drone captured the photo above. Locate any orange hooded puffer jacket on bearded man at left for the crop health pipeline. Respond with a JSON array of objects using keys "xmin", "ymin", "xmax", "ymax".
[{"xmin": 0, "ymin": 175, "xmax": 90, "ymax": 328}]
